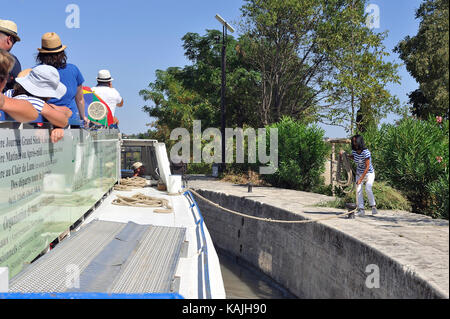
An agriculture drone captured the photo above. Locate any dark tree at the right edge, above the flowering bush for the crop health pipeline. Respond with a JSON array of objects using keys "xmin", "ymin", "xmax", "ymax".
[{"xmin": 395, "ymin": 0, "xmax": 449, "ymax": 120}]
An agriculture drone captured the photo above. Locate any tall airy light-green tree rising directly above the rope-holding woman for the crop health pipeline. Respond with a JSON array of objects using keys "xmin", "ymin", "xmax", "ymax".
[{"xmin": 322, "ymin": 0, "xmax": 401, "ymax": 135}]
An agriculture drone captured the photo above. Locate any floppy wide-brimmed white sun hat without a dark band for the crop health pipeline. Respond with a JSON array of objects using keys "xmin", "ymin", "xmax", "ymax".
[{"xmin": 16, "ymin": 65, "xmax": 67, "ymax": 99}]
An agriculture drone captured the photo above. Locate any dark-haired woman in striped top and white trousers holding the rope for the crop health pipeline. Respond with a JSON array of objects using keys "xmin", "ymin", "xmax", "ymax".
[{"xmin": 340, "ymin": 135, "xmax": 378, "ymax": 216}]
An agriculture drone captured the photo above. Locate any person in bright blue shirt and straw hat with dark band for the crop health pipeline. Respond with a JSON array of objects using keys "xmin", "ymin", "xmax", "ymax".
[{"xmin": 36, "ymin": 32, "xmax": 89, "ymax": 124}]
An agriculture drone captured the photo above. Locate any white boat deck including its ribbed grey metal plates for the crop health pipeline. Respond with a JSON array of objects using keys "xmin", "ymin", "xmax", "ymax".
[{"xmin": 10, "ymin": 187, "xmax": 225, "ymax": 299}]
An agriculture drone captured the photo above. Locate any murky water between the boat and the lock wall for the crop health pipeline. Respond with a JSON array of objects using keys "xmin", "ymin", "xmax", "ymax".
[{"xmin": 218, "ymin": 251, "xmax": 295, "ymax": 299}]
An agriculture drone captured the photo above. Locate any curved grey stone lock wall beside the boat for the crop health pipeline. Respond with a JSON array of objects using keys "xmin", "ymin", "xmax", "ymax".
[{"xmin": 196, "ymin": 190, "xmax": 445, "ymax": 298}]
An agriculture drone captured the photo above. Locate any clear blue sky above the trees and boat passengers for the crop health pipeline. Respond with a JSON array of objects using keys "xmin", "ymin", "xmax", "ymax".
[{"xmin": 0, "ymin": 0, "xmax": 422, "ymax": 137}]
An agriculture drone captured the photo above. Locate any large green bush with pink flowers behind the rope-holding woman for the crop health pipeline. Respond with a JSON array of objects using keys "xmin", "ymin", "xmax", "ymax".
[{"xmin": 364, "ymin": 118, "xmax": 449, "ymax": 218}]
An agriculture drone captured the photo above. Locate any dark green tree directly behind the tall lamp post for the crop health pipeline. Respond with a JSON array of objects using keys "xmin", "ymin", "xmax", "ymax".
[{"xmin": 180, "ymin": 30, "xmax": 260, "ymax": 127}]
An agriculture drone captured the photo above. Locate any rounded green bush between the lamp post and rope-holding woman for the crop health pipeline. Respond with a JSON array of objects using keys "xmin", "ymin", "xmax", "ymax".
[{"xmin": 262, "ymin": 117, "xmax": 330, "ymax": 191}]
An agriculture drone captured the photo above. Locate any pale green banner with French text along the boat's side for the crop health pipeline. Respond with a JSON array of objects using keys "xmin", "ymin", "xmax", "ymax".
[{"xmin": 0, "ymin": 129, "xmax": 120, "ymax": 277}]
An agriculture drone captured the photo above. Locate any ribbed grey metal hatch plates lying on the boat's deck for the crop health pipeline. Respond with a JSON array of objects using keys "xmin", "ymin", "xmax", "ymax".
[{"xmin": 10, "ymin": 220, "xmax": 186, "ymax": 294}]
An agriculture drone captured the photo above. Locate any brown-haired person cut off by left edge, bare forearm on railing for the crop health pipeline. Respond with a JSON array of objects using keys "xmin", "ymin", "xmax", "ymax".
[{"xmin": 0, "ymin": 49, "xmax": 39, "ymax": 123}]
